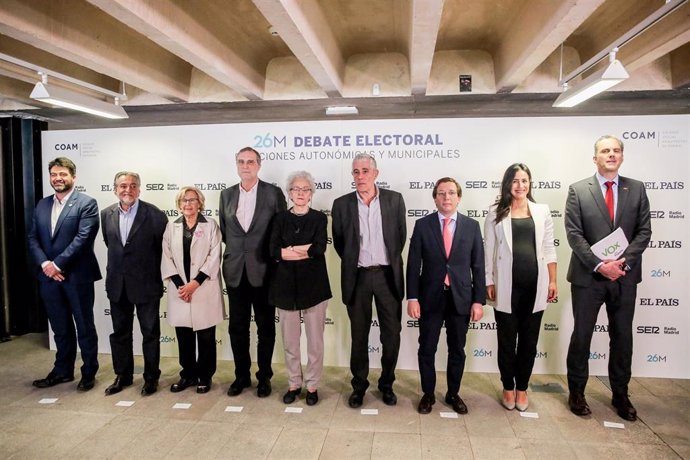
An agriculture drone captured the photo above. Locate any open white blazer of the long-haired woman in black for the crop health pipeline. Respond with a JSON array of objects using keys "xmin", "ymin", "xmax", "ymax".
[{"xmin": 484, "ymin": 201, "xmax": 556, "ymax": 313}]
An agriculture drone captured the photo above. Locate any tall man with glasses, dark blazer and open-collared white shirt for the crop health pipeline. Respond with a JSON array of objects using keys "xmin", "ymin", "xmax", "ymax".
[{"xmin": 219, "ymin": 147, "xmax": 286, "ymax": 398}]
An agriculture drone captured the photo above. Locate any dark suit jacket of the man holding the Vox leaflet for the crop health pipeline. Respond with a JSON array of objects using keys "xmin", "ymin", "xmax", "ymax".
[{"xmin": 565, "ymin": 175, "xmax": 652, "ymax": 286}]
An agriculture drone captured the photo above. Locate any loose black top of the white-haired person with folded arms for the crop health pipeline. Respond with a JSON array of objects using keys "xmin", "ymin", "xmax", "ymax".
[{"xmin": 268, "ymin": 209, "xmax": 332, "ymax": 310}]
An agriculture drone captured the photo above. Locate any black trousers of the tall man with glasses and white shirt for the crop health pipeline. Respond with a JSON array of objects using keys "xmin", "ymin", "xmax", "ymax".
[{"xmin": 228, "ymin": 271, "xmax": 276, "ymax": 383}]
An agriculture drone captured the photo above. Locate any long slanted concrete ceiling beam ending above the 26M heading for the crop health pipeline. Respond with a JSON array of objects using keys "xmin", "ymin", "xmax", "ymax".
[{"xmin": 87, "ymin": 0, "xmax": 265, "ymax": 100}]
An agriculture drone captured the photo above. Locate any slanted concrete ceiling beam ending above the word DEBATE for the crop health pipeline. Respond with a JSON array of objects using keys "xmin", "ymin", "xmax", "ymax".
[{"xmin": 253, "ymin": 0, "xmax": 345, "ymax": 97}]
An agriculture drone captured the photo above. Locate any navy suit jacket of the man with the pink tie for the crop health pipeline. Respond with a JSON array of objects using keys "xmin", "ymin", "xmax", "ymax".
[{"xmin": 407, "ymin": 212, "xmax": 486, "ymax": 315}]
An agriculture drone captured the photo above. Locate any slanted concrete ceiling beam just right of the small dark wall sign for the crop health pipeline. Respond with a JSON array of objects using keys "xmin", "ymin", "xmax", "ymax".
[{"xmin": 494, "ymin": 0, "xmax": 604, "ymax": 93}]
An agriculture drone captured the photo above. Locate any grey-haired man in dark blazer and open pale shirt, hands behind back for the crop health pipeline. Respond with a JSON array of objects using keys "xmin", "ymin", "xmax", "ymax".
[{"xmin": 333, "ymin": 154, "xmax": 407, "ymax": 408}]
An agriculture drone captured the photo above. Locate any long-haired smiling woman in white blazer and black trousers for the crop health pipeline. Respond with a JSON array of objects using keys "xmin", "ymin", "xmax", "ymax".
[{"xmin": 484, "ymin": 163, "xmax": 558, "ymax": 411}]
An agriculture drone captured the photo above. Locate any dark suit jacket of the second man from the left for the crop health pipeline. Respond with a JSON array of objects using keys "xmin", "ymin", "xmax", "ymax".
[{"xmin": 101, "ymin": 200, "xmax": 168, "ymax": 304}]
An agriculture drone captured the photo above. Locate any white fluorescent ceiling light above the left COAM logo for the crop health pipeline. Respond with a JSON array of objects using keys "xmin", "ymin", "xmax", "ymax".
[{"xmin": 30, "ymin": 82, "xmax": 129, "ymax": 119}]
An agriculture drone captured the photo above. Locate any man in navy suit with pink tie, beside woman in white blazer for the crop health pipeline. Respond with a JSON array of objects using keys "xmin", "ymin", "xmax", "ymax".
[{"xmin": 407, "ymin": 177, "xmax": 486, "ymax": 414}]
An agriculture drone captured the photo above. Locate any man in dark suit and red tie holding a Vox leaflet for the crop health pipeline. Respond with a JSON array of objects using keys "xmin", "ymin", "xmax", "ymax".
[{"xmin": 565, "ymin": 136, "xmax": 652, "ymax": 421}]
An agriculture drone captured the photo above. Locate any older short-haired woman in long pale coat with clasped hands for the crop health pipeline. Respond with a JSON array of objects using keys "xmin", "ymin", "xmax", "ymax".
[{"xmin": 161, "ymin": 187, "xmax": 225, "ymax": 393}]
